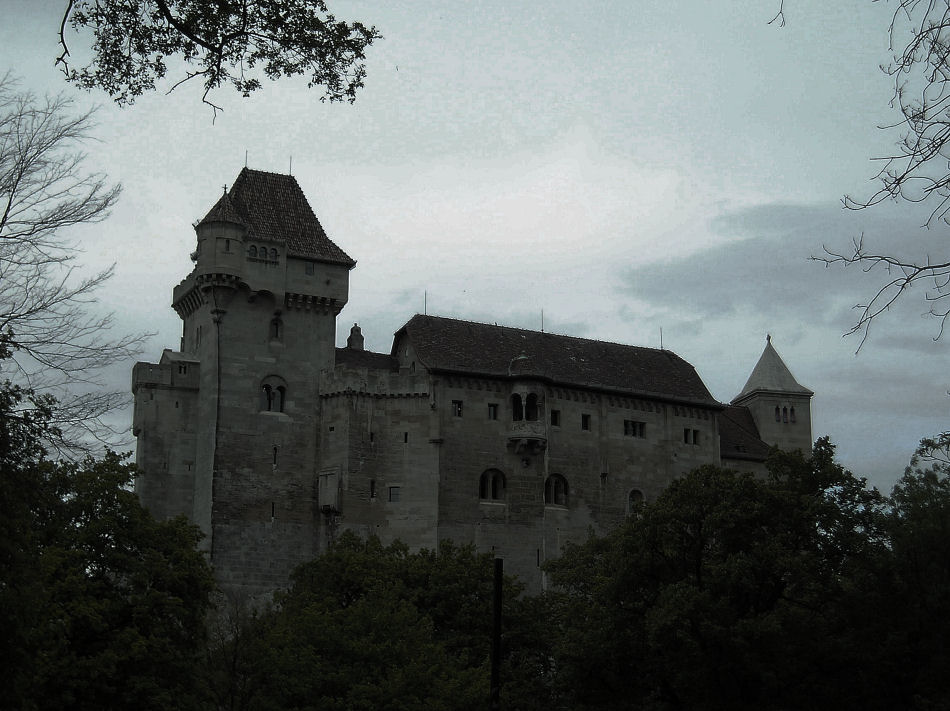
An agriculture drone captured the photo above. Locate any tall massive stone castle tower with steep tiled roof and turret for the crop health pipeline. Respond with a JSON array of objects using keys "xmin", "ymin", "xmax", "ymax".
[{"xmin": 133, "ymin": 168, "xmax": 355, "ymax": 595}]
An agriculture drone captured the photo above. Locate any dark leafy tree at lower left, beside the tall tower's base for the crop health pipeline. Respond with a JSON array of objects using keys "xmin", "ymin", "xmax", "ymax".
[{"xmin": 0, "ymin": 340, "xmax": 213, "ymax": 709}]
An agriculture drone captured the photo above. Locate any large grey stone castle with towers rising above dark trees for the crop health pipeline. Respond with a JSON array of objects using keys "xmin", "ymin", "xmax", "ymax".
[{"xmin": 132, "ymin": 168, "xmax": 812, "ymax": 596}]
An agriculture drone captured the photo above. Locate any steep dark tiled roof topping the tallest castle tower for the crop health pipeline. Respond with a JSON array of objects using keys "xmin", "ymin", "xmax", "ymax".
[{"xmin": 199, "ymin": 168, "xmax": 356, "ymax": 267}]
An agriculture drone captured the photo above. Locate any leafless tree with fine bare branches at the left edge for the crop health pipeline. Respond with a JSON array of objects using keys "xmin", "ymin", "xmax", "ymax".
[{"xmin": 0, "ymin": 75, "xmax": 145, "ymax": 453}]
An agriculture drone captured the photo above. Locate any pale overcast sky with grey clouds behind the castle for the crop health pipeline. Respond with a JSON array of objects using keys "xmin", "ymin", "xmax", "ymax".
[{"xmin": 0, "ymin": 0, "xmax": 950, "ymax": 490}]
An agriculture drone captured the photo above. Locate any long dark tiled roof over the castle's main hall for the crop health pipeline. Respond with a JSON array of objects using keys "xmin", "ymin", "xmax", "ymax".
[{"xmin": 393, "ymin": 314, "xmax": 721, "ymax": 407}]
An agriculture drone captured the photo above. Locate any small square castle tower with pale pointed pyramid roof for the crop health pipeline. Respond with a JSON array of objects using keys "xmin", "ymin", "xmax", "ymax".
[{"xmin": 732, "ymin": 336, "xmax": 814, "ymax": 453}]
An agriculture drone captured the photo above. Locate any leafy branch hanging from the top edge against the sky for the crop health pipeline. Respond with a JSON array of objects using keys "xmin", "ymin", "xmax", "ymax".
[{"xmin": 58, "ymin": 0, "xmax": 380, "ymax": 110}]
